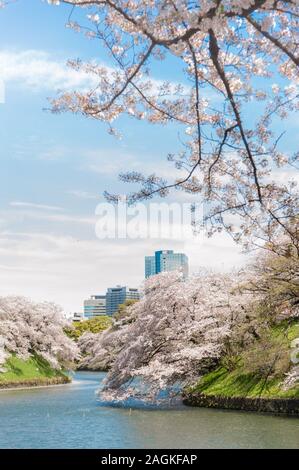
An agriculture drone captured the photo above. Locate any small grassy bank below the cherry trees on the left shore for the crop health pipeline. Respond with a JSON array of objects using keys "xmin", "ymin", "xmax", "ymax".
[{"xmin": 0, "ymin": 356, "xmax": 70, "ymax": 389}]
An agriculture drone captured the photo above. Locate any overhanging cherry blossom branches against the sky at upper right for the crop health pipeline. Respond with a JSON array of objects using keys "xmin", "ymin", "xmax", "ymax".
[{"xmin": 40, "ymin": 0, "xmax": 299, "ymax": 249}]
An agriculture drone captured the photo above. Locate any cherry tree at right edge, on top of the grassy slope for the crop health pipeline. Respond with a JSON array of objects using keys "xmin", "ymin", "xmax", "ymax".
[{"xmin": 238, "ymin": 238, "xmax": 299, "ymax": 390}]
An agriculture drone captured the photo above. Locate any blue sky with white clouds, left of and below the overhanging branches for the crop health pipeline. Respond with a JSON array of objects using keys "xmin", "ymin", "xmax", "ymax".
[{"xmin": 0, "ymin": 0, "xmax": 295, "ymax": 312}]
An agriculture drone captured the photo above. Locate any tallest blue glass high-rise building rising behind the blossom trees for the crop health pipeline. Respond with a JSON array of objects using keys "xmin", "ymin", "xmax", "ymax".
[{"xmin": 144, "ymin": 250, "xmax": 189, "ymax": 278}]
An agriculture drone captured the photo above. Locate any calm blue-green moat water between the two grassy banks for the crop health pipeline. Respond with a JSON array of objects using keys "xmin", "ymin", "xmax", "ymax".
[{"xmin": 0, "ymin": 372, "xmax": 299, "ymax": 449}]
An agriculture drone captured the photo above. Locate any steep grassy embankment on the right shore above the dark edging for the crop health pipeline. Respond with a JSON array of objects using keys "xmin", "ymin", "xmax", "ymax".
[{"xmin": 187, "ymin": 322, "xmax": 299, "ymax": 398}]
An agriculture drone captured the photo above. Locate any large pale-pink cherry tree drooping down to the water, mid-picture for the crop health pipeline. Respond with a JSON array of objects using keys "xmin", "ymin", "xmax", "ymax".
[{"xmin": 90, "ymin": 272, "xmax": 244, "ymax": 401}]
